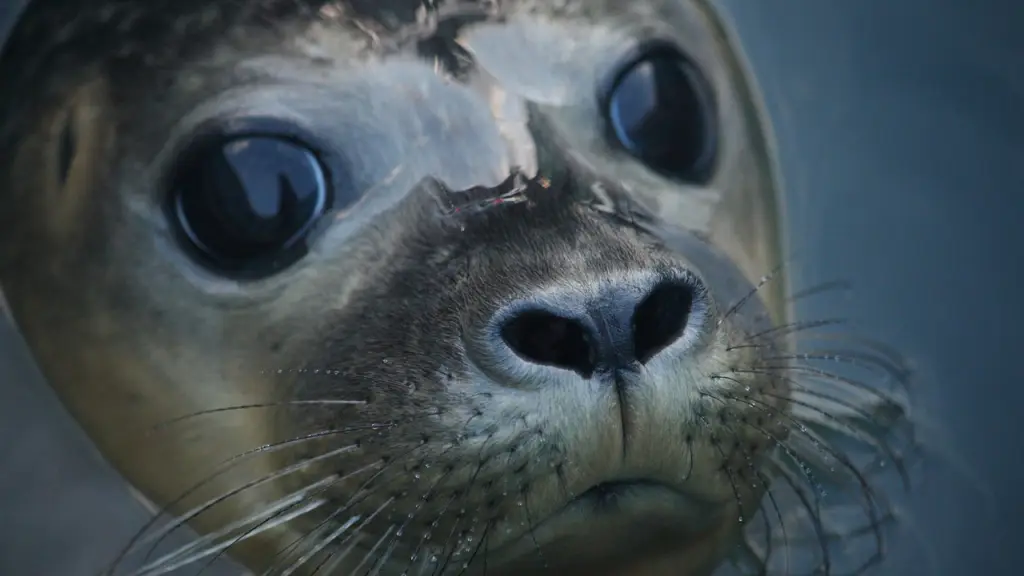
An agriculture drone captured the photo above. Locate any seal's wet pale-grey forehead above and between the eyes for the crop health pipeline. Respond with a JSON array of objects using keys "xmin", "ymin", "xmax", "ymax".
[{"xmin": 0, "ymin": 0, "xmax": 729, "ymax": 201}]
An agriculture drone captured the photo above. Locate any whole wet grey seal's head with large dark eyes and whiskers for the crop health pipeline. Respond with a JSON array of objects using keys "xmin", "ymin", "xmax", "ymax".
[{"xmin": 0, "ymin": 0, "xmax": 908, "ymax": 576}]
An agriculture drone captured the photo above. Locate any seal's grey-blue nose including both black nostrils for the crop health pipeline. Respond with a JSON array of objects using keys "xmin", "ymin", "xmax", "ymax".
[{"xmin": 493, "ymin": 279, "xmax": 697, "ymax": 378}]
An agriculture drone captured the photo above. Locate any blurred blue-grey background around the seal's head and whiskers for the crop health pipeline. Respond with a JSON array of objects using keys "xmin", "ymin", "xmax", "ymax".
[{"xmin": 0, "ymin": 0, "xmax": 1024, "ymax": 576}]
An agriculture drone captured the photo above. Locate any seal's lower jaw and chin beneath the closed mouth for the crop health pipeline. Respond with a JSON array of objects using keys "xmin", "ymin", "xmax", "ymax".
[{"xmin": 292, "ymin": 489, "xmax": 741, "ymax": 576}]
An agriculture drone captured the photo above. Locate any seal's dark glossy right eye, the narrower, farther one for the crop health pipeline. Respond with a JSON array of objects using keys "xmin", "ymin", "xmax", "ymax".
[{"xmin": 602, "ymin": 43, "xmax": 718, "ymax": 181}]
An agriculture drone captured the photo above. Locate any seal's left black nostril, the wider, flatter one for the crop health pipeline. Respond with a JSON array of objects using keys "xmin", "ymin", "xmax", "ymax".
[{"xmin": 501, "ymin": 310, "xmax": 597, "ymax": 378}]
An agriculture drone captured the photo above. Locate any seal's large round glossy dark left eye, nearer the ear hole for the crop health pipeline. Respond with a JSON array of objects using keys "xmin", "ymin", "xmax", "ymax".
[{"xmin": 176, "ymin": 136, "xmax": 326, "ymax": 260}]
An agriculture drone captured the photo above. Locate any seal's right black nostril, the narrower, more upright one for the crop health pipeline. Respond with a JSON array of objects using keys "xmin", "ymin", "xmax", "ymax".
[{"xmin": 633, "ymin": 283, "xmax": 693, "ymax": 364}]
